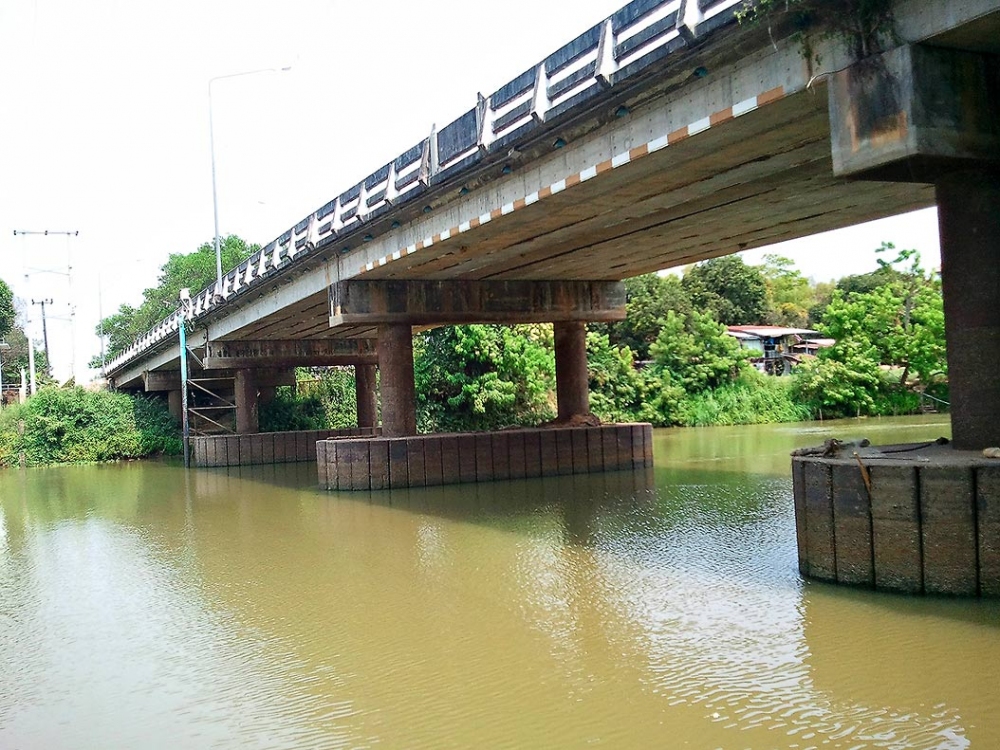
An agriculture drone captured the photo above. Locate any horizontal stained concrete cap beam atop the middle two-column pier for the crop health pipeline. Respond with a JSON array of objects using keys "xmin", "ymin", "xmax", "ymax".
[{"xmin": 330, "ymin": 279, "xmax": 625, "ymax": 326}]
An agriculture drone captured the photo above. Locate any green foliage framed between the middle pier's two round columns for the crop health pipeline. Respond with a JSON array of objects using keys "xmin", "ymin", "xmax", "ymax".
[{"xmin": 414, "ymin": 325, "xmax": 555, "ymax": 432}]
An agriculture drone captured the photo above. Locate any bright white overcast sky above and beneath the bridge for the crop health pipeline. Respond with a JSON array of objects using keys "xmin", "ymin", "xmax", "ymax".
[{"xmin": 0, "ymin": 0, "xmax": 938, "ymax": 379}]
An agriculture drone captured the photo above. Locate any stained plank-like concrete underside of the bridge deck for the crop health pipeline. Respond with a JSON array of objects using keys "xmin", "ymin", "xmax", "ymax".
[{"xmin": 225, "ymin": 85, "xmax": 934, "ymax": 340}]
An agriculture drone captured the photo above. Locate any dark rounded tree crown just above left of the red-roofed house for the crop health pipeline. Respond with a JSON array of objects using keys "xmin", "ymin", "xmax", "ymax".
[{"xmin": 681, "ymin": 255, "xmax": 767, "ymax": 325}]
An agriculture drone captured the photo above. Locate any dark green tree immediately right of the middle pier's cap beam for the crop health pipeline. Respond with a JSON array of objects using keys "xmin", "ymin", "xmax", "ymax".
[{"xmin": 591, "ymin": 273, "xmax": 691, "ymax": 360}]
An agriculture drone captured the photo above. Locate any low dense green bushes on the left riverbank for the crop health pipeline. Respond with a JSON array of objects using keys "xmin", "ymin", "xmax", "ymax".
[{"xmin": 0, "ymin": 387, "xmax": 181, "ymax": 466}]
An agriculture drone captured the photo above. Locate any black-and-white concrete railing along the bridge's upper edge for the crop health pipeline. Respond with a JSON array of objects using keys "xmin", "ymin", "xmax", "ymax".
[{"xmin": 106, "ymin": 0, "xmax": 743, "ymax": 373}]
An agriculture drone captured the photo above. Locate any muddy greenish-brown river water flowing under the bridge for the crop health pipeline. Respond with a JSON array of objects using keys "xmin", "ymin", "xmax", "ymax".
[{"xmin": 0, "ymin": 417, "xmax": 1000, "ymax": 750}]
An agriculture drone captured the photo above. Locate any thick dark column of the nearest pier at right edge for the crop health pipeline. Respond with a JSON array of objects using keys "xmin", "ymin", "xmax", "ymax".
[{"xmin": 936, "ymin": 171, "xmax": 1000, "ymax": 450}]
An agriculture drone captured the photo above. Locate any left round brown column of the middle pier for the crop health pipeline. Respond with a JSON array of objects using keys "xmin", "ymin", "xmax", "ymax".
[{"xmin": 378, "ymin": 323, "xmax": 417, "ymax": 437}]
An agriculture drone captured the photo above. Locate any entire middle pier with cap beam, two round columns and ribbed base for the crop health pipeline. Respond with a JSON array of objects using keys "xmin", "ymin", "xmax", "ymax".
[{"xmin": 317, "ymin": 280, "xmax": 653, "ymax": 490}]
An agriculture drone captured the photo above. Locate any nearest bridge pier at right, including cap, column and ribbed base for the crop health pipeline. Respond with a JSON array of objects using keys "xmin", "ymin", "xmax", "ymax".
[{"xmin": 792, "ymin": 46, "xmax": 1000, "ymax": 596}]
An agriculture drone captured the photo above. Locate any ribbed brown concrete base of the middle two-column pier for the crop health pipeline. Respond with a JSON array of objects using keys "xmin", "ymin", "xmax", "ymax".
[{"xmin": 317, "ymin": 424, "xmax": 653, "ymax": 490}]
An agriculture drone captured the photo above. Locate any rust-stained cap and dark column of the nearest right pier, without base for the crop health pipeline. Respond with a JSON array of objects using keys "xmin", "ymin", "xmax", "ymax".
[{"xmin": 829, "ymin": 45, "xmax": 1000, "ymax": 450}]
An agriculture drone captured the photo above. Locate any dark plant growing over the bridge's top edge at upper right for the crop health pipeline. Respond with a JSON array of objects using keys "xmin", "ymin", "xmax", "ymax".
[{"xmin": 736, "ymin": 0, "xmax": 896, "ymax": 60}]
